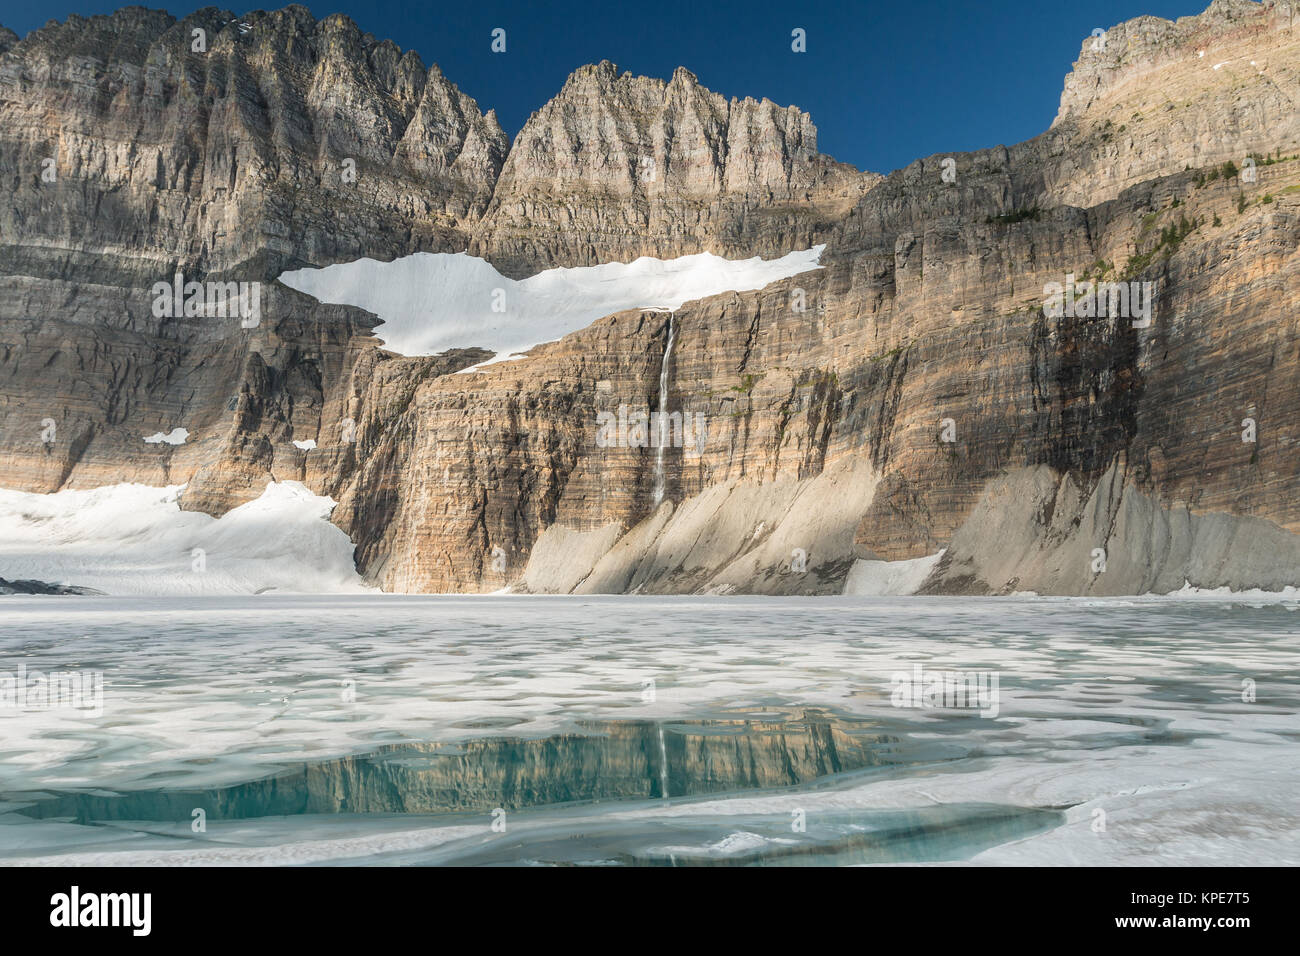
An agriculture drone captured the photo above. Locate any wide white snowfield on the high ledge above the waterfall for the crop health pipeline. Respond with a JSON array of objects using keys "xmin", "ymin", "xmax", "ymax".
[{"xmin": 280, "ymin": 245, "xmax": 826, "ymax": 371}]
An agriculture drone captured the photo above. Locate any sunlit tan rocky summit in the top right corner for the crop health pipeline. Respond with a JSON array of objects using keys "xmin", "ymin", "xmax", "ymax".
[{"xmin": 1045, "ymin": 0, "xmax": 1300, "ymax": 207}]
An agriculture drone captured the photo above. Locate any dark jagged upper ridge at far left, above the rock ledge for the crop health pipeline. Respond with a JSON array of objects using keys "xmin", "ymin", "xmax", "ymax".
[{"xmin": 0, "ymin": 7, "xmax": 507, "ymax": 280}]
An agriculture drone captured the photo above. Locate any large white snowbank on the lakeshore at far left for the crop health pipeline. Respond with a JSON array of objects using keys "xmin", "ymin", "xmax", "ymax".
[{"xmin": 0, "ymin": 481, "xmax": 369, "ymax": 594}]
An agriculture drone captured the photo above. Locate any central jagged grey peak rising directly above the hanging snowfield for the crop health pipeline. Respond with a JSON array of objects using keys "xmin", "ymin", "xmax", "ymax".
[{"xmin": 472, "ymin": 60, "xmax": 878, "ymax": 277}]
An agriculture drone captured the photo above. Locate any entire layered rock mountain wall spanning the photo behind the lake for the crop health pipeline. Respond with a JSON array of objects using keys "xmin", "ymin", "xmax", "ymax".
[{"xmin": 0, "ymin": 0, "xmax": 1300, "ymax": 593}]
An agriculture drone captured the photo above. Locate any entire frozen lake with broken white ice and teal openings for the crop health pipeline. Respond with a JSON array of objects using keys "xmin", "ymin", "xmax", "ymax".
[{"xmin": 0, "ymin": 594, "xmax": 1300, "ymax": 865}]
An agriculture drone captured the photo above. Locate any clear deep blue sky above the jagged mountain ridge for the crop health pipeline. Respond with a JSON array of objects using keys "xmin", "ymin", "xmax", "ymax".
[{"xmin": 0, "ymin": 0, "xmax": 1209, "ymax": 173}]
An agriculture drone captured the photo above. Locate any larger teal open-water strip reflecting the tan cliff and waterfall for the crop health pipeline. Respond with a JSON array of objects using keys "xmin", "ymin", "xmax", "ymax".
[{"xmin": 12, "ymin": 710, "xmax": 900, "ymax": 823}]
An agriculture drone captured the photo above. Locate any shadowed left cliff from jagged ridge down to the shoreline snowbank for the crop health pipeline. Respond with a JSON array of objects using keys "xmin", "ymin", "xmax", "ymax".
[{"xmin": 0, "ymin": 7, "xmax": 507, "ymax": 511}]
